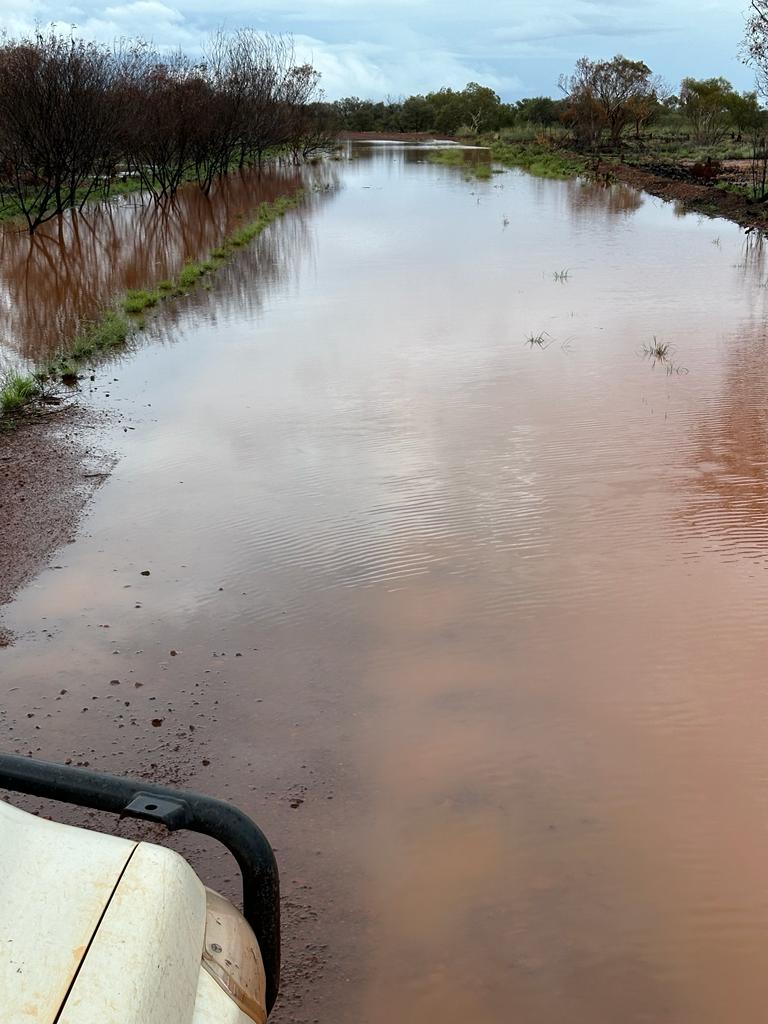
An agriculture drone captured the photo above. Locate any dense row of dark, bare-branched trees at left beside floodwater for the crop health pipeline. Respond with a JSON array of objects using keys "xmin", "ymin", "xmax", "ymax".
[{"xmin": 0, "ymin": 29, "xmax": 329, "ymax": 231}]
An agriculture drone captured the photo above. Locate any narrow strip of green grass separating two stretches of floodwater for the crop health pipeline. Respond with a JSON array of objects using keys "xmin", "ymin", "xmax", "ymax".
[{"xmin": 0, "ymin": 191, "xmax": 303, "ymax": 425}]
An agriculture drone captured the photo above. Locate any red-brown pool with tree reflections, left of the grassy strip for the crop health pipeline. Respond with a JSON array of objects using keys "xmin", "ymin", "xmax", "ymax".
[{"xmin": 0, "ymin": 166, "xmax": 318, "ymax": 359}]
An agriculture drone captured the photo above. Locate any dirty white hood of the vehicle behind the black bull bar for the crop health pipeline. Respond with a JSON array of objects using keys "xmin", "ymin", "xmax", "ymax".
[{"xmin": 0, "ymin": 802, "xmax": 218, "ymax": 1024}]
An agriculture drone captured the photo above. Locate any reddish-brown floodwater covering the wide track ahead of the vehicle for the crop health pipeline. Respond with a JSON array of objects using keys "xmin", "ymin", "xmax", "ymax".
[{"xmin": 0, "ymin": 145, "xmax": 768, "ymax": 1024}]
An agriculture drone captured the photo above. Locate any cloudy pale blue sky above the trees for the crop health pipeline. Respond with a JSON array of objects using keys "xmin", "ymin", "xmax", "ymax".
[{"xmin": 6, "ymin": 0, "xmax": 753, "ymax": 100}]
